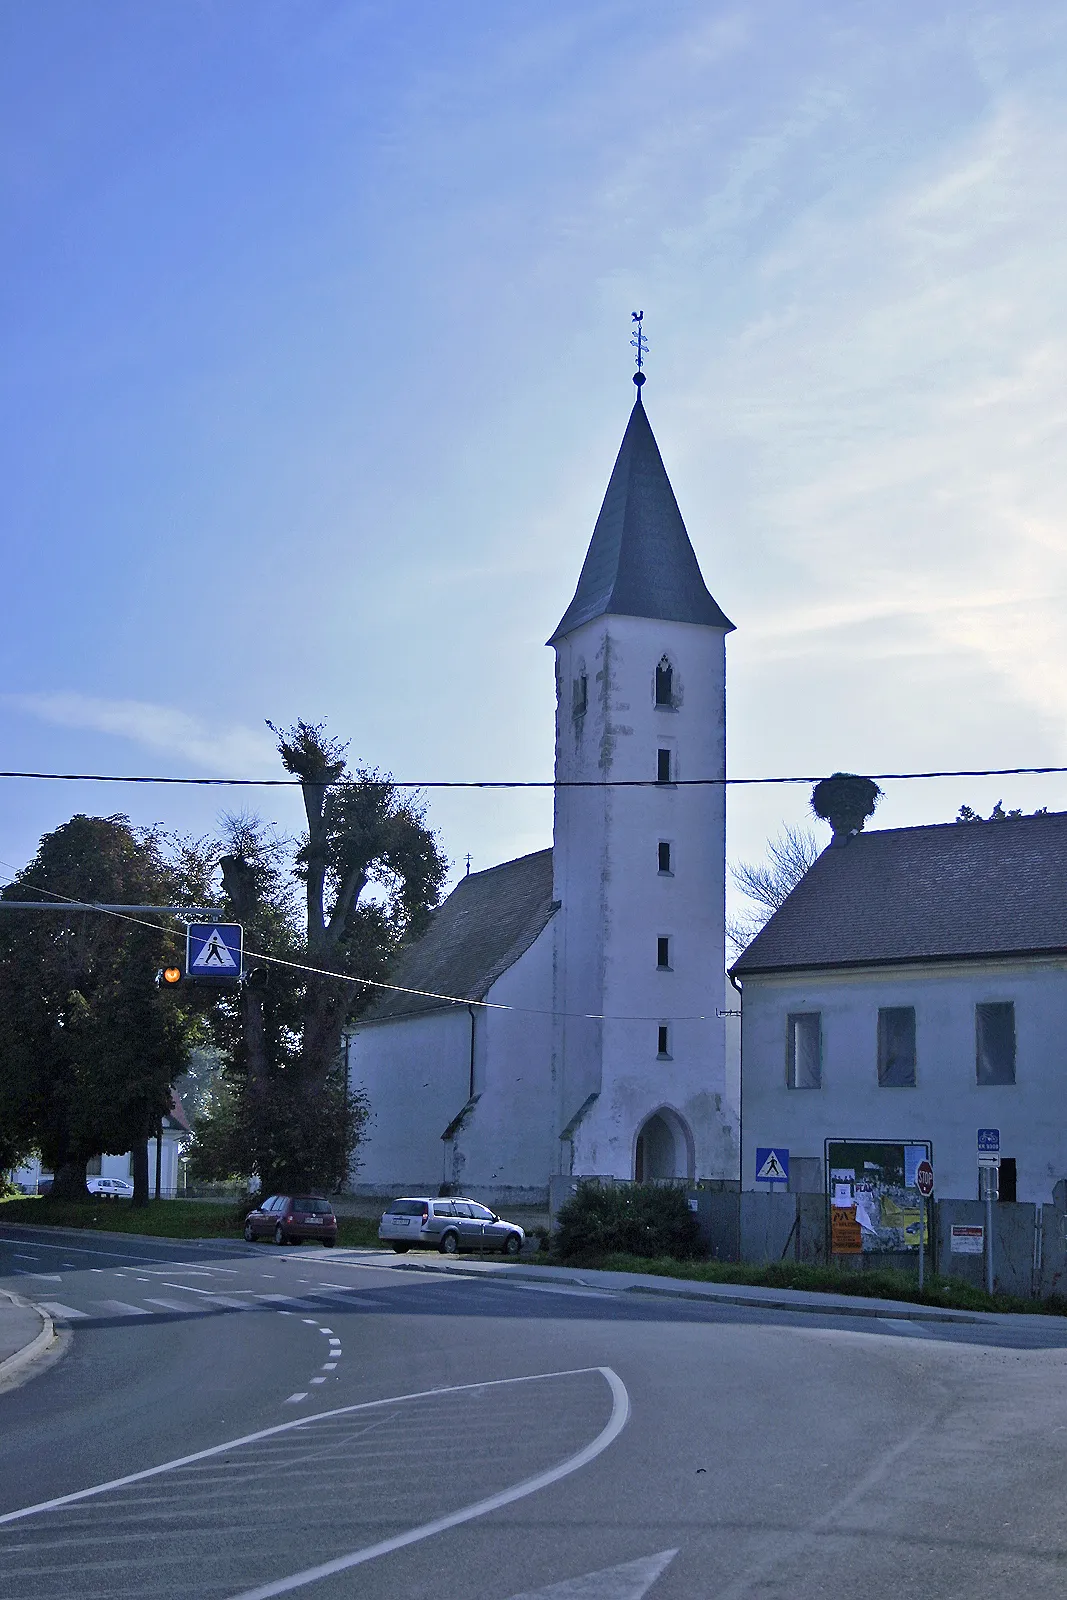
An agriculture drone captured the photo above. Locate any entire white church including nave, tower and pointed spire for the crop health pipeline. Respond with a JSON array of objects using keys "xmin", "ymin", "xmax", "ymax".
[{"xmin": 349, "ymin": 371, "xmax": 739, "ymax": 1205}]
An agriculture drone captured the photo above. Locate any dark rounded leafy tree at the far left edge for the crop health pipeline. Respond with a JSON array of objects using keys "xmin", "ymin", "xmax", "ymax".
[{"xmin": 0, "ymin": 816, "xmax": 195, "ymax": 1197}]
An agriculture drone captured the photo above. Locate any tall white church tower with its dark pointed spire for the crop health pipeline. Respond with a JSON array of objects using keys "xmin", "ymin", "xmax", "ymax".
[{"xmin": 549, "ymin": 368, "xmax": 736, "ymax": 1179}]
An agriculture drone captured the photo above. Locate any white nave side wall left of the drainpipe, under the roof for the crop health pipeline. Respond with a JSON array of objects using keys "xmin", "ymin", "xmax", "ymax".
[{"xmin": 349, "ymin": 1006, "xmax": 470, "ymax": 1195}]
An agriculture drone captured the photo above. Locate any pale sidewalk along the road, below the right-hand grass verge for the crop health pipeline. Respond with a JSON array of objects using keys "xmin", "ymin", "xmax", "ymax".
[{"xmin": 375, "ymin": 1251, "xmax": 1041, "ymax": 1326}]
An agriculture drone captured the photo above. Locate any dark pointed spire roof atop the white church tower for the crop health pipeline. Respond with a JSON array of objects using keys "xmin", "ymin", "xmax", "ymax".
[{"xmin": 549, "ymin": 393, "xmax": 734, "ymax": 645}]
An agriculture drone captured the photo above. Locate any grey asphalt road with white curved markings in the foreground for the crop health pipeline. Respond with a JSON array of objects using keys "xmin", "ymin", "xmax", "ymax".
[{"xmin": 0, "ymin": 1229, "xmax": 1067, "ymax": 1600}]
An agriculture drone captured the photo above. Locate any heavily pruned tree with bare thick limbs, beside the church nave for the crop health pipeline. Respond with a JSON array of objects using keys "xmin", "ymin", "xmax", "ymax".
[{"xmin": 194, "ymin": 722, "xmax": 446, "ymax": 1189}]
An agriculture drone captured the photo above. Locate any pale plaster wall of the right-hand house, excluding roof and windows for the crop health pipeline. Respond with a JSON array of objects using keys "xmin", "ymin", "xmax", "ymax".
[{"xmin": 742, "ymin": 960, "xmax": 1067, "ymax": 1203}]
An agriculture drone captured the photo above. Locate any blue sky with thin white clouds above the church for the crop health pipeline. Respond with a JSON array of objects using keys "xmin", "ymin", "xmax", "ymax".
[{"xmin": 0, "ymin": 0, "xmax": 1067, "ymax": 902}]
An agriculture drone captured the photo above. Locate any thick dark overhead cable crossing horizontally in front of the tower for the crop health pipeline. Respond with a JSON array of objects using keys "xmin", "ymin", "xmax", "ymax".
[{"xmin": 0, "ymin": 766, "xmax": 1067, "ymax": 789}]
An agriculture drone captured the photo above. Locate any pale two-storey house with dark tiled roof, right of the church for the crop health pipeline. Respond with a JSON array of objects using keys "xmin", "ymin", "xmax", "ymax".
[{"xmin": 733, "ymin": 813, "xmax": 1067, "ymax": 1203}]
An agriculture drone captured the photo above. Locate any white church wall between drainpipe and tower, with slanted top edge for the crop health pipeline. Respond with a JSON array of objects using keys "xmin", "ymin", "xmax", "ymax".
[{"xmin": 451, "ymin": 923, "xmax": 557, "ymax": 1206}]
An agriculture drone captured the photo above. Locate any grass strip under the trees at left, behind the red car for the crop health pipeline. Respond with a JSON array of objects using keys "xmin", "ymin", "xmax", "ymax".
[{"xmin": 0, "ymin": 1195, "xmax": 378, "ymax": 1246}]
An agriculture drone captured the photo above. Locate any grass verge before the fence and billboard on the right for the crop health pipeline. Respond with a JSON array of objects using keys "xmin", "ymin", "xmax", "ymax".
[{"xmin": 560, "ymin": 1256, "xmax": 1067, "ymax": 1317}]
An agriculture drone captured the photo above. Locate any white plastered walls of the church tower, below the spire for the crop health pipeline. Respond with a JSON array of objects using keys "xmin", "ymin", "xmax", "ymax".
[{"xmin": 553, "ymin": 616, "xmax": 737, "ymax": 1178}]
